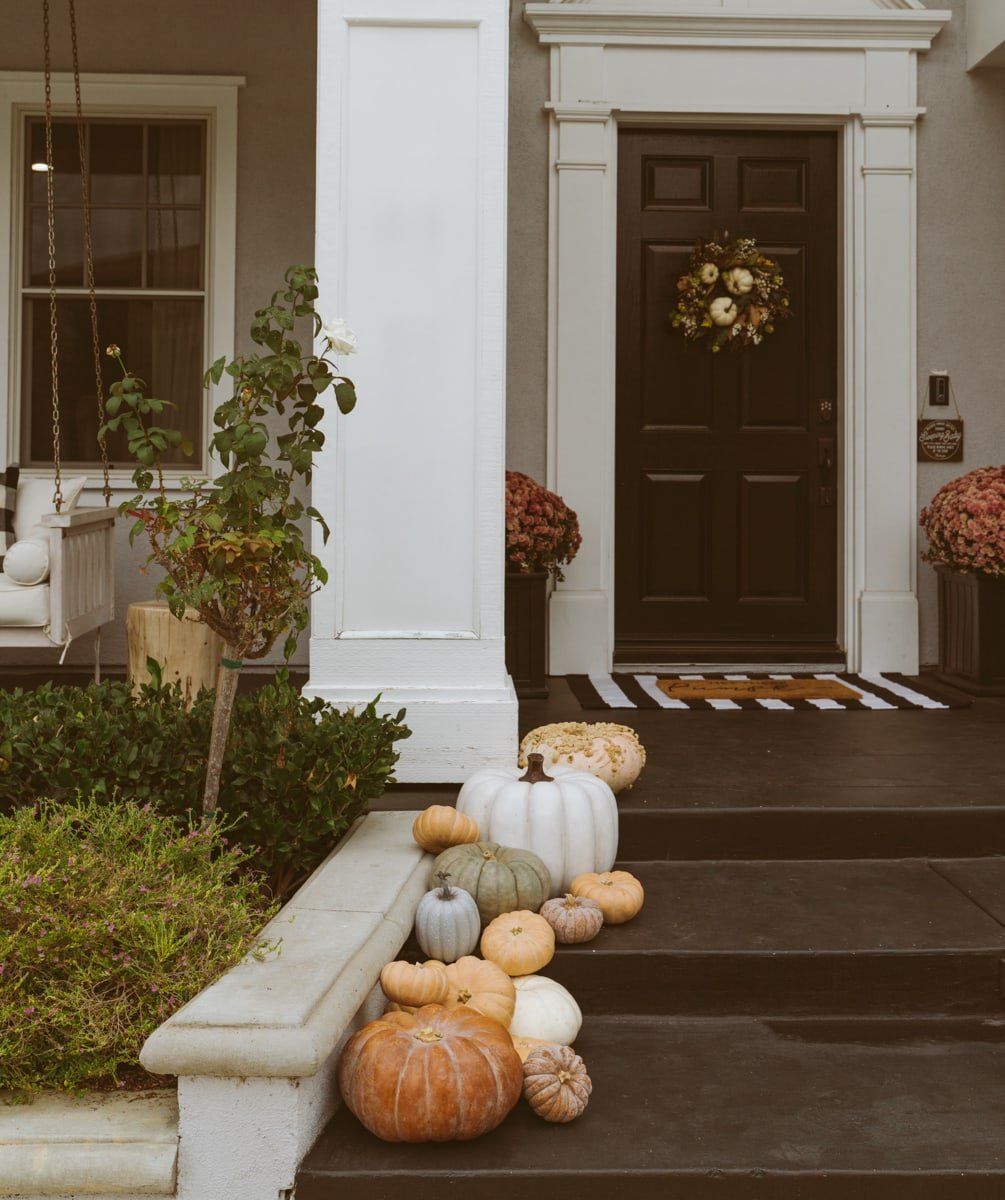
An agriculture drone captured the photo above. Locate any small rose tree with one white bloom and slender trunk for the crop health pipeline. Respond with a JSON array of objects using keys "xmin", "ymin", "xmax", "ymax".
[{"xmin": 103, "ymin": 266, "xmax": 356, "ymax": 812}]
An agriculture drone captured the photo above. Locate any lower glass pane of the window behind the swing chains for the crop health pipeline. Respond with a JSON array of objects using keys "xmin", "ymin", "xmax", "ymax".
[{"xmin": 22, "ymin": 298, "xmax": 204, "ymax": 470}]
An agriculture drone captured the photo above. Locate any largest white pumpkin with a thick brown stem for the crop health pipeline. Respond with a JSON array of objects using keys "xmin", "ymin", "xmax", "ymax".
[{"xmin": 457, "ymin": 754, "xmax": 618, "ymax": 895}]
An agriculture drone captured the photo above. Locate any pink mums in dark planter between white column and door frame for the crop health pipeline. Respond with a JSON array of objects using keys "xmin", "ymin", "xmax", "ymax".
[{"xmin": 506, "ymin": 470, "xmax": 583, "ymax": 697}]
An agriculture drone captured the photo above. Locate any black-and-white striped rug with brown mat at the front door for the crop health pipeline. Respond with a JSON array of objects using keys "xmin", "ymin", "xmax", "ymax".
[{"xmin": 566, "ymin": 673, "xmax": 970, "ymax": 713}]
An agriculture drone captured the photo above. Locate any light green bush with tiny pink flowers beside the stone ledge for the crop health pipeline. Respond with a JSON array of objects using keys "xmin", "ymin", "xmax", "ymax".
[{"xmin": 0, "ymin": 798, "xmax": 273, "ymax": 1092}]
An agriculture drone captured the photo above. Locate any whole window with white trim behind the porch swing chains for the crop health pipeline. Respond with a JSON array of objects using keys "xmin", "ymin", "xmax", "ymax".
[{"xmin": 0, "ymin": 76, "xmax": 242, "ymax": 484}]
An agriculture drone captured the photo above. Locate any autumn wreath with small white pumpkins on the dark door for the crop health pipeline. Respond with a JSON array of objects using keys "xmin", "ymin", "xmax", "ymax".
[{"xmin": 670, "ymin": 234, "xmax": 790, "ymax": 353}]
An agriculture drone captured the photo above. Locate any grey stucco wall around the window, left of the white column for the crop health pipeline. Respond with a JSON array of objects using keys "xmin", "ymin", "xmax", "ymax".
[{"xmin": 0, "ymin": 0, "xmax": 317, "ymax": 666}]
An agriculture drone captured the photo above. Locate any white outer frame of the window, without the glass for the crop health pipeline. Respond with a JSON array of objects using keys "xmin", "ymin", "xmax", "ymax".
[{"xmin": 0, "ymin": 72, "xmax": 245, "ymax": 497}]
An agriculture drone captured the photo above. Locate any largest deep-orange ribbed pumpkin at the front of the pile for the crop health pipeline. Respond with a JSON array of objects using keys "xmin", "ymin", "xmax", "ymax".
[{"xmin": 338, "ymin": 1004, "xmax": 523, "ymax": 1142}]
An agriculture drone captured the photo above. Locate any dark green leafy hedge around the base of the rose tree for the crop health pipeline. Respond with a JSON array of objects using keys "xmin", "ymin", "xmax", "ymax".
[{"xmin": 0, "ymin": 671, "xmax": 410, "ymax": 895}]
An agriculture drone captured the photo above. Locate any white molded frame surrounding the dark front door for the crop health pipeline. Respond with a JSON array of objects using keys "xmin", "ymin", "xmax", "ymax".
[{"xmin": 525, "ymin": 0, "xmax": 952, "ymax": 674}]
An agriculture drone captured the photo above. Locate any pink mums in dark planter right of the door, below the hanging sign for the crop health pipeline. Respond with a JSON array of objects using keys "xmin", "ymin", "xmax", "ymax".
[{"xmin": 921, "ymin": 467, "xmax": 1005, "ymax": 695}]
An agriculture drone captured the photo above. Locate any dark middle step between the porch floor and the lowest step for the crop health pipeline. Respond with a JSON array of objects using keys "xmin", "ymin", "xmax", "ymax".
[{"xmin": 543, "ymin": 859, "xmax": 1005, "ymax": 1015}]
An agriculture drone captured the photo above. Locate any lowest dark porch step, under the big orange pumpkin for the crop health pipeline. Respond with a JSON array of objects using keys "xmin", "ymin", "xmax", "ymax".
[{"xmin": 295, "ymin": 1015, "xmax": 1005, "ymax": 1200}]
